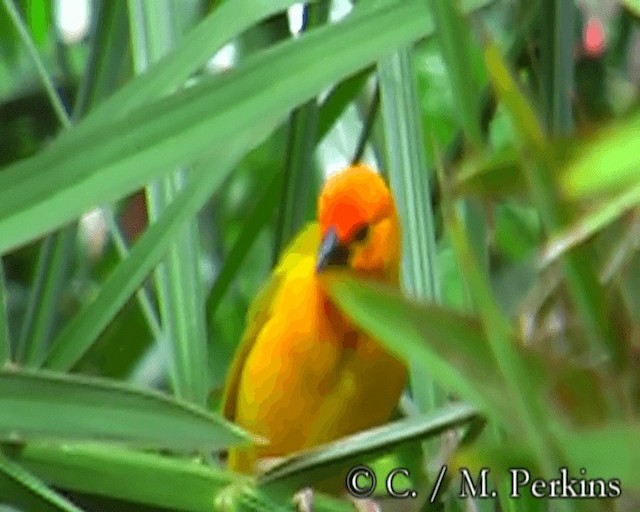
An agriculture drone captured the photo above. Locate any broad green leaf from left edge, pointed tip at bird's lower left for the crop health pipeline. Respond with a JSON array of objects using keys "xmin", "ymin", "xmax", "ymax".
[{"xmin": 0, "ymin": 370, "xmax": 248, "ymax": 450}]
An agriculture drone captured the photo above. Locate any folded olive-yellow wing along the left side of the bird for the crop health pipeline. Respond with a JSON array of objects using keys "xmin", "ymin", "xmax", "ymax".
[{"xmin": 222, "ymin": 222, "xmax": 320, "ymax": 421}]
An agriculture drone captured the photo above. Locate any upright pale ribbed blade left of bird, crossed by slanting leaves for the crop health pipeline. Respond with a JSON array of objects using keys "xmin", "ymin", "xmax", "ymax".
[{"xmin": 129, "ymin": 0, "xmax": 209, "ymax": 406}]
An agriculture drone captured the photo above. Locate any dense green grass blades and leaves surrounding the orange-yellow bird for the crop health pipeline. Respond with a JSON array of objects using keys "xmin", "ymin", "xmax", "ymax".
[{"xmin": 0, "ymin": 0, "xmax": 640, "ymax": 512}]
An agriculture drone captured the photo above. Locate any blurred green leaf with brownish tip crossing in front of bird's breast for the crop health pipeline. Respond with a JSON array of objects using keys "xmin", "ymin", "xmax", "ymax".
[{"xmin": 322, "ymin": 274, "xmax": 512, "ymax": 423}]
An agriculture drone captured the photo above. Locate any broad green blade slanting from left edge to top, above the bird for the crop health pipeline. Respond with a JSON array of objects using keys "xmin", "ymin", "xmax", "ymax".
[{"xmin": 0, "ymin": 1, "xmax": 426, "ymax": 251}]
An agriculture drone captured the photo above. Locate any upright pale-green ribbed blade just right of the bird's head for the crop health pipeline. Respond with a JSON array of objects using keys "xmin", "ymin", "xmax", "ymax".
[{"xmin": 378, "ymin": 49, "xmax": 446, "ymax": 420}]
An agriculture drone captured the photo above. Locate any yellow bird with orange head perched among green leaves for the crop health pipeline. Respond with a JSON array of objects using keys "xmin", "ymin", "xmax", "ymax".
[{"xmin": 221, "ymin": 163, "xmax": 407, "ymax": 492}]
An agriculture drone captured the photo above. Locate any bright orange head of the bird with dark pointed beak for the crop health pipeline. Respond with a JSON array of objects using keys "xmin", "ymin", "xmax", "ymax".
[{"xmin": 316, "ymin": 164, "xmax": 400, "ymax": 275}]
